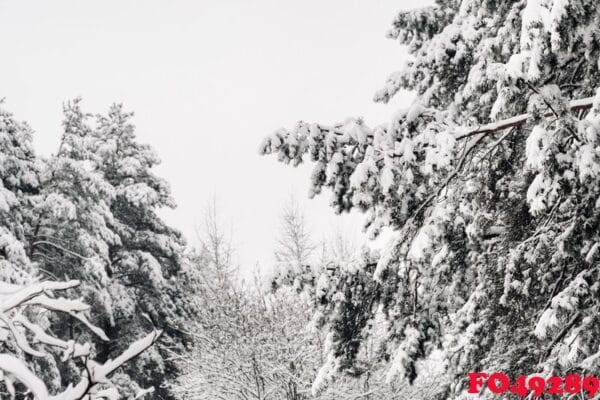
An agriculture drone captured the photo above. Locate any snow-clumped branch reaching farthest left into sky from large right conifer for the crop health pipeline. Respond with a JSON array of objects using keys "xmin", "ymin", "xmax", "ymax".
[{"xmin": 259, "ymin": 93, "xmax": 594, "ymax": 237}]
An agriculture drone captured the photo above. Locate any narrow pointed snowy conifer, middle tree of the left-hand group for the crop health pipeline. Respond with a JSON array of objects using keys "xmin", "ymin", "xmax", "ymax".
[{"xmin": 27, "ymin": 101, "xmax": 123, "ymax": 386}]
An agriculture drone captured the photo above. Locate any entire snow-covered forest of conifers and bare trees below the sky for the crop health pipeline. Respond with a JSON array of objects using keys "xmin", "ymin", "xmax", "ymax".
[{"xmin": 0, "ymin": 0, "xmax": 600, "ymax": 400}]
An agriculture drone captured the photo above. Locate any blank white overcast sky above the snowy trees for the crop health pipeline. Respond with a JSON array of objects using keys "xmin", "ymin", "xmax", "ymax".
[{"xmin": 0, "ymin": 0, "xmax": 426, "ymax": 276}]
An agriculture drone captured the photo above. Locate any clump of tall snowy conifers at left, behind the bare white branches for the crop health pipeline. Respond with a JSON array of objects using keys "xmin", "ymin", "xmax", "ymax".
[{"xmin": 0, "ymin": 100, "xmax": 202, "ymax": 398}]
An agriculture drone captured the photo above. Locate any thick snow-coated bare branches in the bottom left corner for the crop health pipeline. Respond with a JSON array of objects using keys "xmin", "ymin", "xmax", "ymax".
[{"xmin": 0, "ymin": 280, "xmax": 161, "ymax": 400}]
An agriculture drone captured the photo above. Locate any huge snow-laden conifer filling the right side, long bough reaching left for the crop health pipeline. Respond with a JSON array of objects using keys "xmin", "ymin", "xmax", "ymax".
[{"xmin": 261, "ymin": 0, "xmax": 600, "ymax": 398}]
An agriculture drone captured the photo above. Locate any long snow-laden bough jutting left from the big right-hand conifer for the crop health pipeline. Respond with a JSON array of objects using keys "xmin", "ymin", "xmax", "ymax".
[{"xmin": 259, "ymin": 93, "xmax": 594, "ymax": 237}]
